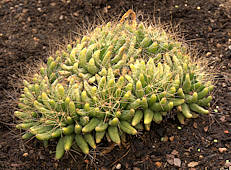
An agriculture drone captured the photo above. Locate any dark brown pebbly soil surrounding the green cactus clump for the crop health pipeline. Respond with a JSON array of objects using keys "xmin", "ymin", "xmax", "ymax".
[{"xmin": 0, "ymin": 0, "xmax": 231, "ymax": 170}]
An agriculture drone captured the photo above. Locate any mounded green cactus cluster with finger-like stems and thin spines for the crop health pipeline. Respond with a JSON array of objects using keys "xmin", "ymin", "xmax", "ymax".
[{"xmin": 15, "ymin": 11, "xmax": 213, "ymax": 159}]
